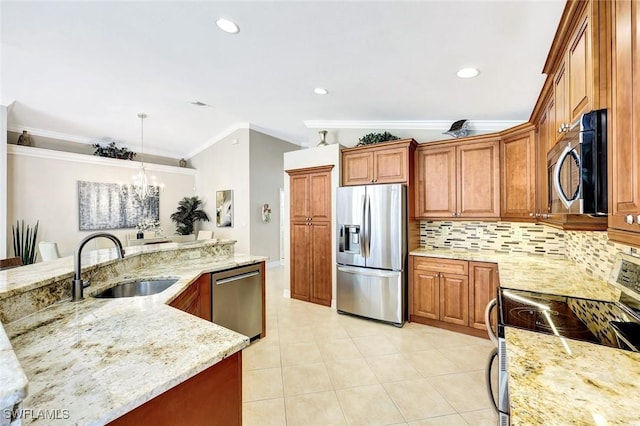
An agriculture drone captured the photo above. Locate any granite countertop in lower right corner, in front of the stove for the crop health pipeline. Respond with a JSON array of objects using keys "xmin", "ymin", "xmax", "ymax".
[{"xmin": 505, "ymin": 327, "xmax": 640, "ymax": 425}]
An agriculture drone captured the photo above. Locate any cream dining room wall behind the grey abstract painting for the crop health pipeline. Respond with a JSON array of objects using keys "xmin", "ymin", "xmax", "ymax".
[{"xmin": 4, "ymin": 146, "xmax": 195, "ymax": 256}]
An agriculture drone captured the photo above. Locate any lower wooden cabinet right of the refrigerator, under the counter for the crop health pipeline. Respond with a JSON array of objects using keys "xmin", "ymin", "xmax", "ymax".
[{"xmin": 409, "ymin": 256, "xmax": 498, "ymax": 337}]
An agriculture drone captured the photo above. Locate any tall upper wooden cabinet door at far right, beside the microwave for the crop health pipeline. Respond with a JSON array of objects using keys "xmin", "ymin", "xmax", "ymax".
[{"xmin": 609, "ymin": 1, "xmax": 640, "ymax": 233}]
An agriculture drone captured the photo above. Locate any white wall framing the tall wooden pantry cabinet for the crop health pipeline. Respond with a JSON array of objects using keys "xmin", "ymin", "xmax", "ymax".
[{"xmin": 282, "ymin": 144, "xmax": 343, "ymax": 308}]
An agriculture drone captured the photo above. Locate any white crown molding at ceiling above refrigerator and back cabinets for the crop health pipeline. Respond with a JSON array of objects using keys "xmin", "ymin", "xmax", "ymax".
[{"xmin": 304, "ymin": 120, "xmax": 525, "ymax": 132}]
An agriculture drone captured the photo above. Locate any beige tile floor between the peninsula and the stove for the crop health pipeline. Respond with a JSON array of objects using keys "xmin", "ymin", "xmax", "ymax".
[{"xmin": 242, "ymin": 267, "xmax": 497, "ymax": 426}]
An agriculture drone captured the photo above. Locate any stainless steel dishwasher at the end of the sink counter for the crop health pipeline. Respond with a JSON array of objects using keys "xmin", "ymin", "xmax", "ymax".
[{"xmin": 211, "ymin": 263, "xmax": 263, "ymax": 340}]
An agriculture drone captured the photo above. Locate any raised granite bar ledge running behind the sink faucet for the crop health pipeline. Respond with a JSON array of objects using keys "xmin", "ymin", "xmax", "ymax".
[{"xmin": 0, "ymin": 240, "xmax": 236, "ymax": 299}]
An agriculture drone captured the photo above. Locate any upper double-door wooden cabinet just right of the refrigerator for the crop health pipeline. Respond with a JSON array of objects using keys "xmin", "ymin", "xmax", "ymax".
[{"xmin": 416, "ymin": 135, "xmax": 500, "ymax": 219}]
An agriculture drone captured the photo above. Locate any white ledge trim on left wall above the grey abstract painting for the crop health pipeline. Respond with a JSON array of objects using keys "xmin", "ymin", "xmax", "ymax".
[{"xmin": 7, "ymin": 144, "xmax": 197, "ymax": 176}]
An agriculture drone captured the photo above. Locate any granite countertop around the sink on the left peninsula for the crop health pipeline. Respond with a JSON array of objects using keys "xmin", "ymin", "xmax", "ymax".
[{"xmin": 0, "ymin": 241, "xmax": 266, "ymax": 424}]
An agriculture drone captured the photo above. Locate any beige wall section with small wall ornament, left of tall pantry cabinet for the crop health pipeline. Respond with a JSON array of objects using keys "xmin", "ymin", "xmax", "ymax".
[{"xmin": 249, "ymin": 130, "xmax": 300, "ymax": 262}]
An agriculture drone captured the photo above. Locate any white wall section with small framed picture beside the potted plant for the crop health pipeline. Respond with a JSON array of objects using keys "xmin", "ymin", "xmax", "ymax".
[{"xmin": 189, "ymin": 129, "xmax": 251, "ymax": 254}]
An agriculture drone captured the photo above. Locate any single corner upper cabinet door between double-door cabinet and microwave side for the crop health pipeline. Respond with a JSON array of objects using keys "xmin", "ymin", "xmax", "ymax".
[{"xmin": 500, "ymin": 131, "xmax": 537, "ymax": 220}]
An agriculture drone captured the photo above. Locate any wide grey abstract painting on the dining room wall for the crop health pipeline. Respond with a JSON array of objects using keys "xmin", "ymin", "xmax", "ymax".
[{"xmin": 78, "ymin": 181, "xmax": 160, "ymax": 231}]
